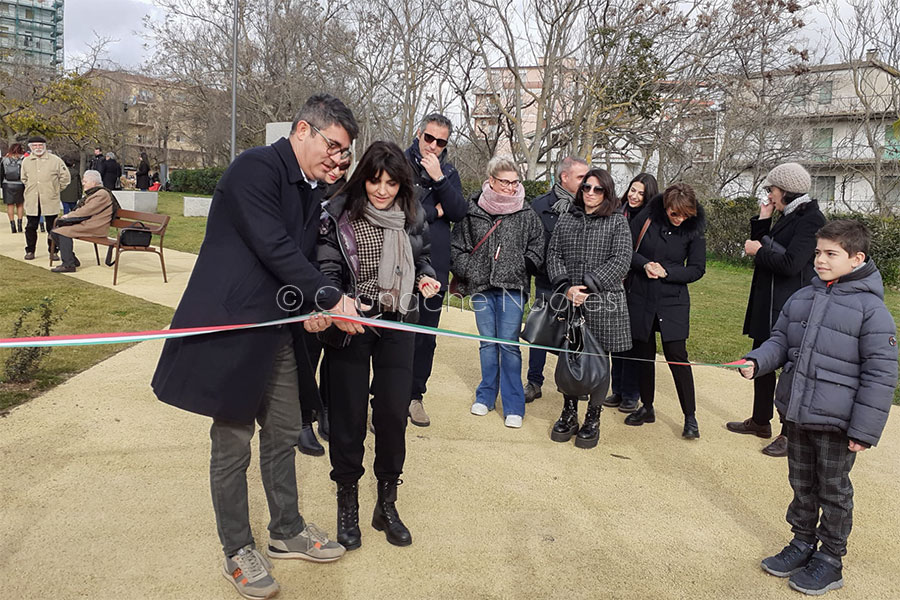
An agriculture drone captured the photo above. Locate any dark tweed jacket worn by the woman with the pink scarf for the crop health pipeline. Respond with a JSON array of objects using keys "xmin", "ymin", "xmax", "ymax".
[{"xmin": 450, "ymin": 192, "xmax": 544, "ymax": 294}]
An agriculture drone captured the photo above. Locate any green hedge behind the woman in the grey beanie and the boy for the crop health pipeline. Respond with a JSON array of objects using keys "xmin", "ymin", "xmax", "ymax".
[{"xmin": 703, "ymin": 198, "xmax": 900, "ymax": 286}]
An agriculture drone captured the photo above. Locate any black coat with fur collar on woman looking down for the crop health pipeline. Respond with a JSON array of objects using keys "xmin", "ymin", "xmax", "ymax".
[{"xmin": 626, "ymin": 194, "xmax": 706, "ymax": 342}]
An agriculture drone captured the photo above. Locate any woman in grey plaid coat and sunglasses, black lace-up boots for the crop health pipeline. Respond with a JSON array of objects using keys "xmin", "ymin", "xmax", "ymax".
[{"xmin": 547, "ymin": 169, "xmax": 632, "ymax": 448}]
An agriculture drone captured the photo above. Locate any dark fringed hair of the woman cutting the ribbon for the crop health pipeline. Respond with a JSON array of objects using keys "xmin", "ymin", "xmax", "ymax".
[{"xmin": 341, "ymin": 142, "xmax": 419, "ymax": 225}]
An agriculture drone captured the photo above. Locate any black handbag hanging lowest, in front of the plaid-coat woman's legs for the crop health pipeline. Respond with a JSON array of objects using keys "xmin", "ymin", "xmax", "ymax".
[{"xmin": 556, "ymin": 307, "xmax": 609, "ymax": 396}]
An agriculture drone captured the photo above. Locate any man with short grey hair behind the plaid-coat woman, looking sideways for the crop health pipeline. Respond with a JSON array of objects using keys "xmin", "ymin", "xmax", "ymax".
[{"xmin": 525, "ymin": 156, "xmax": 588, "ymax": 402}]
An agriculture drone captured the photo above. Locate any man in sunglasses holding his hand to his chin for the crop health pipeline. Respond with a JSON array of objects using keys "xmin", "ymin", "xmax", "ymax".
[{"xmin": 406, "ymin": 113, "xmax": 468, "ymax": 427}]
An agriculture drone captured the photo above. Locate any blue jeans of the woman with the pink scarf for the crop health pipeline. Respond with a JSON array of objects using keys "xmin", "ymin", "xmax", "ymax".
[{"xmin": 472, "ymin": 288, "xmax": 527, "ymax": 416}]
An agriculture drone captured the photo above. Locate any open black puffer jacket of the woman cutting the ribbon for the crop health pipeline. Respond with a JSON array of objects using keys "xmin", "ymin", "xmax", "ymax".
[{"xmin": 316, "ymin": 194, "xmax": 434, "ymax": 323}]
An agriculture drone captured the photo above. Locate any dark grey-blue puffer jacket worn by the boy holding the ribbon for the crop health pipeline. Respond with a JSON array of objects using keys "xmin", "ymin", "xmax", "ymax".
[{"xmin": 746, "ymin": 260, "xmax": 897, "ymax": 446}]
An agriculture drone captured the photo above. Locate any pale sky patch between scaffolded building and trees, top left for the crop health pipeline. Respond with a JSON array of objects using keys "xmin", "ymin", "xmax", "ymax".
[{"xmin": 65, "ymin": 0, "xmax": 164, "ymax": 69}]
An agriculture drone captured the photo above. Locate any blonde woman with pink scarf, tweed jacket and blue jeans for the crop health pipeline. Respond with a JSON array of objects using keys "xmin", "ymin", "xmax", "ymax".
[{"xmin": 450, "ymin": 156, "xmax": 544, "ymax": 428}]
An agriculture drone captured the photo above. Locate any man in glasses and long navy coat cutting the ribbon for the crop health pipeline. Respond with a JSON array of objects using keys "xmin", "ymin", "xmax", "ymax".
[{"xmin": 152, "ymin": 94, "xmax": 361, "ymax": 598}]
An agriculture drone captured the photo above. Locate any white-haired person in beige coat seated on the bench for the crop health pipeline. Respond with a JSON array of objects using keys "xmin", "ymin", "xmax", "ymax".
[{"xmin": 50, "ymin": 171, "xmax": 115, "ymax": 273}]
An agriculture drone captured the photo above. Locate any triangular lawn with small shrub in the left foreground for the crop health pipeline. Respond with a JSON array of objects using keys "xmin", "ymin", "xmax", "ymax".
[{"xmin": 0, "ymin": 256, "xmax": 174, "ymax": 413}]
